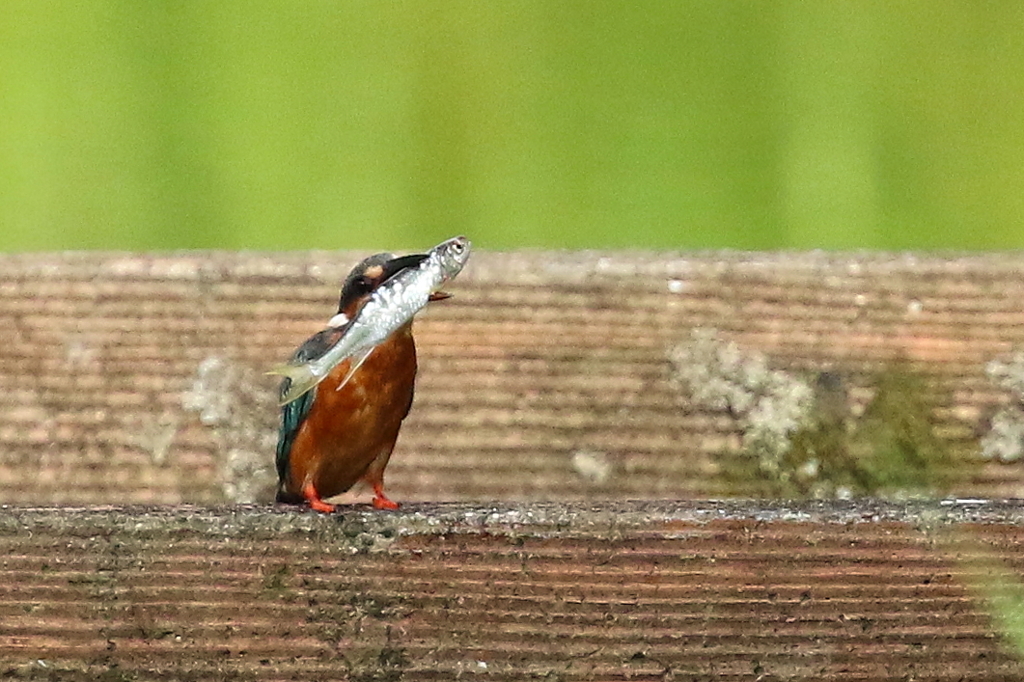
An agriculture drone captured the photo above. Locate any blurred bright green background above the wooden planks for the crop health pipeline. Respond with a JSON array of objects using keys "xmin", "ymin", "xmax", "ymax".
[{"xmin": 0, "ymin": 0, "xmax": 1024, "ymax": 251}]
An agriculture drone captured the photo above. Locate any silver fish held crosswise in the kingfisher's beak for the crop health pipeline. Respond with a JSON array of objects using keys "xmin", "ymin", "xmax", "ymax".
[{"xmin": 267, "ymin": 237, "xmax": 470, "ymax": 406}]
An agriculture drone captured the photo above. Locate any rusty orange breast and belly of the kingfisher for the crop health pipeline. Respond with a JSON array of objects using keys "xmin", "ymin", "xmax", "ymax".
[{"xmin": 286, "ymin": 323, "xmax": 416, "ymax": 498}]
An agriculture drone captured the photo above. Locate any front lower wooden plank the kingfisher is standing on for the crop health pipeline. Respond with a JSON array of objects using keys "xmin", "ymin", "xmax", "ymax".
[{"xmin": 0, "ymin": 502, "xmax": 1024, "ymax": 682}]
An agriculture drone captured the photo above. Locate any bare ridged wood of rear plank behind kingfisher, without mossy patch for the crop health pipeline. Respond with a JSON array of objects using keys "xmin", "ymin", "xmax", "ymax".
[{"xmin": 0, "ymin": 246, "xmax": 1024, "ymax": 504}]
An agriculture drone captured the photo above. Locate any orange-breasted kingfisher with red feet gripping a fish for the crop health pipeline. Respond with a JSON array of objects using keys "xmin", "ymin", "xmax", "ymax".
[{"xmin": 276, "ymin": 253, "xmax": 450, "ymax": 512}]
